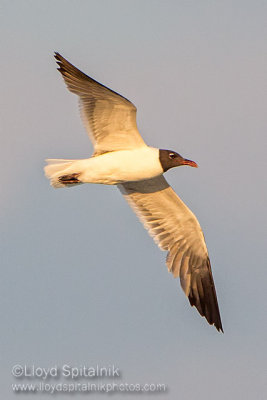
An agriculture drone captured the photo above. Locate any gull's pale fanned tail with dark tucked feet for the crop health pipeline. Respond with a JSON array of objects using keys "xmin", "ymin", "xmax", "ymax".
[{"xmin": 44, "ymin": 159, "xmax": 82, "ymax": 188}]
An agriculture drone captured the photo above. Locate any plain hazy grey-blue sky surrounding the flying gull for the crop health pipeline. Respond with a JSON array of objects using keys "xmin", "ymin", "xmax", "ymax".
[{"xmin": 0, "ymin": 0, "xmax": 267, "ymax": 400}]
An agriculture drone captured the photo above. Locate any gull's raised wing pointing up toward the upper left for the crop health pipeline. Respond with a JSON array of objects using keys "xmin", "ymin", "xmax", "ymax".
[{"xmin": 55, "ymin": 53, "xmax": 145, "ymax": 155}]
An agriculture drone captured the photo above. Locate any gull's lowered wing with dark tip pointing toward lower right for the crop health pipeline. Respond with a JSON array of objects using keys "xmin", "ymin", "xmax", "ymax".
[{"xmin": 118, "ymin": 176, "xmax": 223, "ymax": 331}]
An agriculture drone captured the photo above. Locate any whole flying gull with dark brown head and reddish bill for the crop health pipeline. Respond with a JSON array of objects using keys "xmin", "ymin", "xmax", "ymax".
[{"xmin": 45, "ymin": 53, "xmax": 223, "ymax": 332}]
